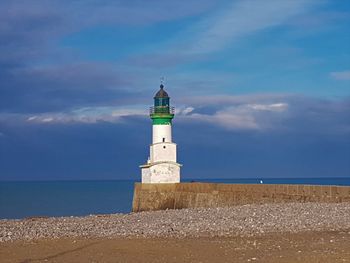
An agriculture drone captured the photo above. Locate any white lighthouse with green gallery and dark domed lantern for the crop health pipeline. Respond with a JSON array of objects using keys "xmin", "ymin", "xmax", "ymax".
[{"xmin": 140, "ymin": 84, "xmax": 181, "ymax": 183}]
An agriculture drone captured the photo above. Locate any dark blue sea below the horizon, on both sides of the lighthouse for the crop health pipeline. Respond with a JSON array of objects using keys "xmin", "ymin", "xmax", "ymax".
[{"xmin": 0, "ymin": 177, "xmax": 350, "ymax": 219}]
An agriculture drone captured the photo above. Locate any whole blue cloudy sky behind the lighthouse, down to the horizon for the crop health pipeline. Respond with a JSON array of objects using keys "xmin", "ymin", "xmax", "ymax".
[{"xmin": 0, "ymin": 0, "xmax": 350, "ymax": 180}]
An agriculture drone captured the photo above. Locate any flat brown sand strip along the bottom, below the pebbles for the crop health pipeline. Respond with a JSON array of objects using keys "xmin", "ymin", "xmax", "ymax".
[{"xmin": 0, "ymin": 232, "xmax": 350, "ymax": 263}]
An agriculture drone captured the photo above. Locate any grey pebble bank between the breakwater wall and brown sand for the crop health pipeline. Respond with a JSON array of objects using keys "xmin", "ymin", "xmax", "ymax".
[{"xmin": 0, "ymin": 203, "xmax": 350, "ymax": 242}]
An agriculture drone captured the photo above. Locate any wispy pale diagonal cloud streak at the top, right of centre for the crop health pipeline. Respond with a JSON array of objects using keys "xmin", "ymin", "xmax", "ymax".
[{"xmin": 188, "ymin": 0, "xmax": 316, "ymax": 53}]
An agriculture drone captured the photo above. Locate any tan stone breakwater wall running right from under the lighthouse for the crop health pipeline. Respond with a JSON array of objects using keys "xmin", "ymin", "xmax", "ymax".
[{"xmin": 132, "ymin": 183, "xmax": 350, "ymax": 212}]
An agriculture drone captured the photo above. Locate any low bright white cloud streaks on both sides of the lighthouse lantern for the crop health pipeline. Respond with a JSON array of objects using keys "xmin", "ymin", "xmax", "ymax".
[{"xmin": 21, "ymin": 96, "xmax": 288, "ymax": 130}]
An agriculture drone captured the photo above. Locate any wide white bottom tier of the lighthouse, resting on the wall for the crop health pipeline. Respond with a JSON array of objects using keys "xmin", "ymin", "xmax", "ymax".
[{"xmin": 140, "ymin": 162, "xmax": 181, "ymax": 184}]
